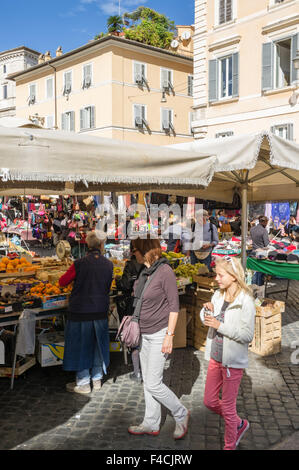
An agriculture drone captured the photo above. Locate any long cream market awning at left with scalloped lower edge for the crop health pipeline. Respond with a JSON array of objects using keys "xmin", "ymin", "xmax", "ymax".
[{"xmin": 0, "ymin": 127, "xmax": 216, "ymax": 194}]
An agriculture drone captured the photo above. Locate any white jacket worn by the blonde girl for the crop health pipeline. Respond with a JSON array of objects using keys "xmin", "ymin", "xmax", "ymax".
[{"xmin": 199, "ymin": 290, "xmax": 256, "ymax": 369}]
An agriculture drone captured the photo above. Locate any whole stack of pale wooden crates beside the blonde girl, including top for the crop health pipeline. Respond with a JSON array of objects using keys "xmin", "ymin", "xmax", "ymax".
[{"xmin": 249, "ymin": 299, "xmax": 285, "ymax": 356}]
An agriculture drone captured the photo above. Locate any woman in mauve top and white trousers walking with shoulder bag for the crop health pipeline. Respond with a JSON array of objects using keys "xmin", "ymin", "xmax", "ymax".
[{"xmin": 128, "ymin": 238, "xmax": 190, "ymax": 439}]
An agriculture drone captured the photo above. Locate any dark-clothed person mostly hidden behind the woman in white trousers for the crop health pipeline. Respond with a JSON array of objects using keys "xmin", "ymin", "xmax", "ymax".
[{"xmin": 115, "ymin": 242, "xmax": 144, "ymax": 382}]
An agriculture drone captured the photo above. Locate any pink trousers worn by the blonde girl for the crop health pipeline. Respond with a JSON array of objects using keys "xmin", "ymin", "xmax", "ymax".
[{"xmin": 204, "ymin": 359, "xmax": 243, "ymax": 450}]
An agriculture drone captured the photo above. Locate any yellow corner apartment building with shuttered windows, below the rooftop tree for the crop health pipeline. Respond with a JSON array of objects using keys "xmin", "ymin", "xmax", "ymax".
[{"xmin": 9, "ymin": 26, "xmax": 193, "ymax": 145}]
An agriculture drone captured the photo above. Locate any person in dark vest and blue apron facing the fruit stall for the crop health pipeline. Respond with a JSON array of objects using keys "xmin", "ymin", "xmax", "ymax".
[{"xmin": 59, "ymin": 232, "xmax": 113, "ymax": 394}]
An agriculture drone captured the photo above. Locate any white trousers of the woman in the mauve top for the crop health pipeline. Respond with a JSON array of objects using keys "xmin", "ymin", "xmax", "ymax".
[{"xmin": 140, "ymin": 328, "xmax": 188, "ymax": 431}]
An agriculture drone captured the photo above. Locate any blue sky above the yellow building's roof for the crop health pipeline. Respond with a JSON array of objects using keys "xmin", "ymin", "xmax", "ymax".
[{"xmin": 0, "ymin": 0, "xmax": 194, "ymax": 57}]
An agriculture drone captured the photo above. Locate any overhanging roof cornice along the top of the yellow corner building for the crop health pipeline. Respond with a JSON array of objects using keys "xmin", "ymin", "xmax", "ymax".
[{"xmin": 8, "ymin": 36, "xmax": 193, "ymax": 81}]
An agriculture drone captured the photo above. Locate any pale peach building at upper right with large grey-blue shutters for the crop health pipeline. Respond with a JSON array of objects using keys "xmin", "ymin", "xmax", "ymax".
[{"xmin": 192, "ymin": 0, "xmax": 299, "ymax": 142}]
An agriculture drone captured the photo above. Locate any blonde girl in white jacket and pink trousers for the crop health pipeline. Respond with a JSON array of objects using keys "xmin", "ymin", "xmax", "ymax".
[{"xmin": 200, "ymin": 256, "xmax": 255, "ymax": 450}]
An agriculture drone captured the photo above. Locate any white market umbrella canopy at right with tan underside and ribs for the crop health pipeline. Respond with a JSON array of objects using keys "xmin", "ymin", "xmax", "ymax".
[{"xmin": 168, "ymin": 132, "xmax": 299, "ymax": 203}]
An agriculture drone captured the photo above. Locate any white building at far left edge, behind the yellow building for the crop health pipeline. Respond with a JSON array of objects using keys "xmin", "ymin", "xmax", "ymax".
[{"xmin": 0, "ymin": 46, "xmax": 40, "ymax": 118}]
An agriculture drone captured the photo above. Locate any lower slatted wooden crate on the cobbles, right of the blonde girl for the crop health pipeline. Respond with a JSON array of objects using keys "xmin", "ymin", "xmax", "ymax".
[{"xmin": 249, "ymin": 313, "xmax": 281, "ymax": 356}]
